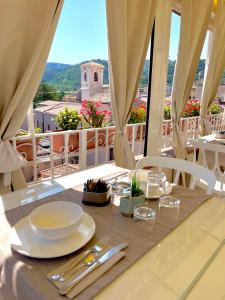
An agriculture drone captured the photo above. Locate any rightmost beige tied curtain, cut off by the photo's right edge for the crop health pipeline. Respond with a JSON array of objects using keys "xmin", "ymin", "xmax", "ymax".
[{"xmin": 200, "ymin": 1, "xmax": 225, "ymax": 135}]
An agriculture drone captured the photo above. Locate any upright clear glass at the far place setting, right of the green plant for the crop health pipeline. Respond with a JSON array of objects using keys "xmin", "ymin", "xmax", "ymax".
[{"xmin": 145, "ymin": 172, "xmax": 166, "ymax": 199}]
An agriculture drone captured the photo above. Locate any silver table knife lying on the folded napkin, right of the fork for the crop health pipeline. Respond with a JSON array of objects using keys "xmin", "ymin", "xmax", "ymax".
[{"xmin": 59, "ymin": 243, "xmax": 128, "ymax": 295}]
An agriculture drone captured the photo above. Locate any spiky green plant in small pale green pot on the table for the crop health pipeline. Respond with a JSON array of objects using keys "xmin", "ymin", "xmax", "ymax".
[{"xmin": 120, "ymin": 174, "xmax": 145, "ymax": 217}]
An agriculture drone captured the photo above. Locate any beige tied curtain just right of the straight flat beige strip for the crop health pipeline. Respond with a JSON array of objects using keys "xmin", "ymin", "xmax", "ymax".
[{"xmin": 172, "ymin": 0, "xmax": 213, "ymax": 159}]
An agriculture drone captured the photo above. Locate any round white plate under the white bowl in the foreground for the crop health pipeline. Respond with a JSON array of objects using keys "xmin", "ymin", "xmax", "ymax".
[{"xmin": 10, "ymin": 213, "xmax": 95, "ymax": 258}]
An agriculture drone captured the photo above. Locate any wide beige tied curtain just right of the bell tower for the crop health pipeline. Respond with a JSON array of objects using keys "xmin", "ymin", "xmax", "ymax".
[{"xmin": 106, "ymin": 0, "xmax": 157, "ymax": 169}]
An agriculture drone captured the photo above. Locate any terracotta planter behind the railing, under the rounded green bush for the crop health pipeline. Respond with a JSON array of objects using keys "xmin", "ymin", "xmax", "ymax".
[{"xmin": 52, "ymin": 130, "xmax": 79, "ymax": 154}]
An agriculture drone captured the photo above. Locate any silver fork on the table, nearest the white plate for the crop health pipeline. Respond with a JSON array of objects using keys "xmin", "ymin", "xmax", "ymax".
[{"xmin": 51, "ymin": 235, "xmax": 110, "ymax": 281}]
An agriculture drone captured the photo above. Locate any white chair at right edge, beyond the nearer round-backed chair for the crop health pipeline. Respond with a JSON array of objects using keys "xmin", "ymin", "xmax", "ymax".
[{"xmin": 192, "ymin": 140, "xmax": 225, "ymax": 194}]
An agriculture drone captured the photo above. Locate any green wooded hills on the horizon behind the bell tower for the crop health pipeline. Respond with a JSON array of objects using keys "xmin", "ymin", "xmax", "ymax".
[{"xmin": 42, "ymin": 59, "xmax": 205, "ymax": 91}]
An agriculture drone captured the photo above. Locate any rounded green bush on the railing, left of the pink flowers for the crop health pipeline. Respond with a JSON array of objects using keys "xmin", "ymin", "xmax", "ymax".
[{"xmin": 56, "ymin": 107, "xmax": 81, "ymax": 130}]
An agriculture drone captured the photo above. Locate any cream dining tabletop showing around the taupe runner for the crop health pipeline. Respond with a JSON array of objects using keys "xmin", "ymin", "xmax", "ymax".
[{"xmin": 0, "ymin": 164, "xmax": 225, "ymax": 300}]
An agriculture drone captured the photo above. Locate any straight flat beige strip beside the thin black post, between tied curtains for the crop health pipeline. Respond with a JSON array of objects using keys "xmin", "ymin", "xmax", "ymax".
[{"xmin": 147, "ymin": 0, "xmax": 173, "ymax": 155}]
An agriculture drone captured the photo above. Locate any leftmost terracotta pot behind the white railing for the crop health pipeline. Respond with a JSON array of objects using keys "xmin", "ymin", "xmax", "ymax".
[{"xmin": 16, "ymin": 128, "xmax": 41, "ymax": 161}]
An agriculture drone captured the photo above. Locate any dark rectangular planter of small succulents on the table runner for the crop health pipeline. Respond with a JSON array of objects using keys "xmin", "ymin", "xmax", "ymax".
[{"xmin": 82, "ymin": 179, "xmax": 110, "ymax": 206}]
